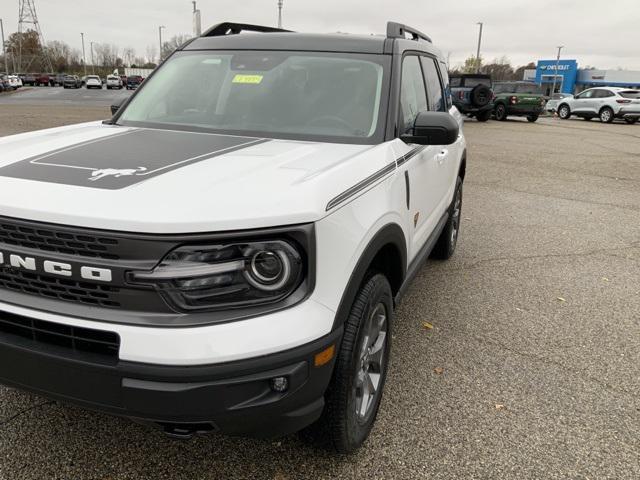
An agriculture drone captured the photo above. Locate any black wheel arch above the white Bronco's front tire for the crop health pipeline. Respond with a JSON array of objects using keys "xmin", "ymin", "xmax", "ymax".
[{"xmin": 332, "ymin": 223, "xmax": 407, "ymax": 330}]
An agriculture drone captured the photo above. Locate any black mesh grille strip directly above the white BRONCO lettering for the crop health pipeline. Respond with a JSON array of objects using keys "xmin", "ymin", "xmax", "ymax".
[{"xmin": 0, "ymin": 221, "xmax": 120, "ymax": 260}]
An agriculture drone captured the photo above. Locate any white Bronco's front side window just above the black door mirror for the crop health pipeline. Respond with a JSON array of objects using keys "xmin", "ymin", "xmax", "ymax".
[{"xmin": 399, "ymin": 55, "xmax": 427, "ymax": 134}]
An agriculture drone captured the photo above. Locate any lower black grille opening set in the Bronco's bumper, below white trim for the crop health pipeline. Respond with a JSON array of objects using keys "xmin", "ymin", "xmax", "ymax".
[{"xmin": 0, "ymin": 312, "xmax": 120, "ymax": 361}]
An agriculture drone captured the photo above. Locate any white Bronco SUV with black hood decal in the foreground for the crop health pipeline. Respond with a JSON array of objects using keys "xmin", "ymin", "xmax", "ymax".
[{"xmin": 0, "ymin": 23, "xmax": 466, "ymax": 452}]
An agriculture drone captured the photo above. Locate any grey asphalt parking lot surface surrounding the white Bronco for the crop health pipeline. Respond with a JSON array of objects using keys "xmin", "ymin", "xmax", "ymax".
[{"xmin": 0, "ymin": 89, "xmax": 640, "ymax": 480}]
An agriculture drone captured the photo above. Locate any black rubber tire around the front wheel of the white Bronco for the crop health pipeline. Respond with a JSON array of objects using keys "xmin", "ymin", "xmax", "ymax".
[{"xmin": 302, "ymin": 272, "xmax": 393, "ymax": 453}]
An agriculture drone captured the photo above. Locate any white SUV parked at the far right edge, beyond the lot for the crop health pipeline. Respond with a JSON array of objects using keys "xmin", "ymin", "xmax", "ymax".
[{"xmin": 558, "ymin": 87, "xmax": 640, "ymax": 124}]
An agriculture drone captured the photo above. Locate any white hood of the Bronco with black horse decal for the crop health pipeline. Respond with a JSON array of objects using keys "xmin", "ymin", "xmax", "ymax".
[{"xmin": 0, "ymin": 122, "xmax": 394, "ymax": 233}]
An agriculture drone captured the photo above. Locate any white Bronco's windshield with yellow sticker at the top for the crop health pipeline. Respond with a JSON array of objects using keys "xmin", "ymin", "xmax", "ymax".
[{"xmin": 118, "ymin": 51, "xmax": 387, "ymax": 143}]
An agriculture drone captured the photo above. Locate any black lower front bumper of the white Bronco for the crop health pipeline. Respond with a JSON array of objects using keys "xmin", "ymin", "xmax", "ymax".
[{"xmin": 0, "ymin": 316, "xmax": 342, "ymax": 437}]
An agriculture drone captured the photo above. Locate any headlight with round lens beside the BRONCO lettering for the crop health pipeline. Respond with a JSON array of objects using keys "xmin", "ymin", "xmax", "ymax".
[{"xmin": 128, "ymin": 240, "xmax": 305, "ymax": 311}]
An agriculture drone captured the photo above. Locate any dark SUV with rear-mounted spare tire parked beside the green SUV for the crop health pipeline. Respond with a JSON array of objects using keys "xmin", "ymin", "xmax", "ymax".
[{"xmin": 449, "ymin": 73, "xmax": 493, "ymax": 122}]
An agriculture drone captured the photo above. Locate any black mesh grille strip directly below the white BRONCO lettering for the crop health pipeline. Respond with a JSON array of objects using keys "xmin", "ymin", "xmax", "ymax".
[{"xmin": 0, "ymin": 267, "xmax": 121, "ymax": 308}]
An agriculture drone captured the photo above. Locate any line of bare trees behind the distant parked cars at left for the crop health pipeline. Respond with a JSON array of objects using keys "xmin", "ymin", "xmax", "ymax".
[{"xmin": 0, "ymin": 30, "xmax": 189, "ymax": 75}]
